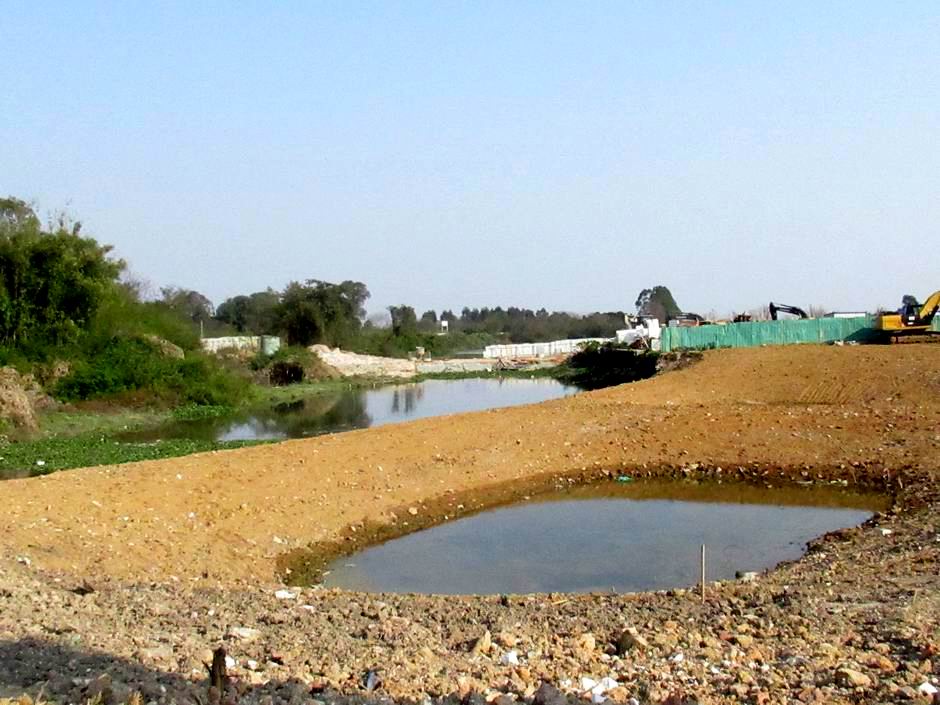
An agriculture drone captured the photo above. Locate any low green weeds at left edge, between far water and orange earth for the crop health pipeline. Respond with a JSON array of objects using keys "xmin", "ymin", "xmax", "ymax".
[{"xmin": 0, "ymin": 434, "xmax": 268, "ymax": 479}]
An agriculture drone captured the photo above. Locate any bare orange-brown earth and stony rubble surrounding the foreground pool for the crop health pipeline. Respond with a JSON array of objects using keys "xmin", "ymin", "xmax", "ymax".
[{"xmin": 0, "ymin": 344, "xmax": 940, "ymax": 705}]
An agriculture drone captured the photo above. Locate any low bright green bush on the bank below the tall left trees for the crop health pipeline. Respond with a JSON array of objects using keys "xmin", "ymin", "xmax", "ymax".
[{"xmin": 54, "ymin": 337, "xmax": 247, "ymax": 406}]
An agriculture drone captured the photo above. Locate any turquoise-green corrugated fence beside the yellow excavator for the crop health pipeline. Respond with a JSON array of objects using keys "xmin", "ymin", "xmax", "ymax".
[{"xmin": 662, "ymin": 316, "xmax": 876, "ymax": 352}]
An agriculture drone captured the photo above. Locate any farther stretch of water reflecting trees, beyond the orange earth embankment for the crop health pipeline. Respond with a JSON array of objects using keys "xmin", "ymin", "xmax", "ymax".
[{"xmin": 121, "ymin": 378, "xmax": 578, "ymax": 441}]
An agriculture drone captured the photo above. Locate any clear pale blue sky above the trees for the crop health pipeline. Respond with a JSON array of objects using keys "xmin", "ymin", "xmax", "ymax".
[{"xmin": 0, "ymin": 0, "xmax": 940, "ymax": 313}]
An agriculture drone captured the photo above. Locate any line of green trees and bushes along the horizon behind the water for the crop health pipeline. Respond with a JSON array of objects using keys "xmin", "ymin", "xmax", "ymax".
[{"xmin": 0, "ymin": 197, "xmax": 677, "ymax": 403}]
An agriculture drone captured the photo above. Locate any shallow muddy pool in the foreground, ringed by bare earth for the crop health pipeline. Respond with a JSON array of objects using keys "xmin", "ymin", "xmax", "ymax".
[{"xmin": 323, "ymin": 482, "xmax": 885, "ymax": 594}]
